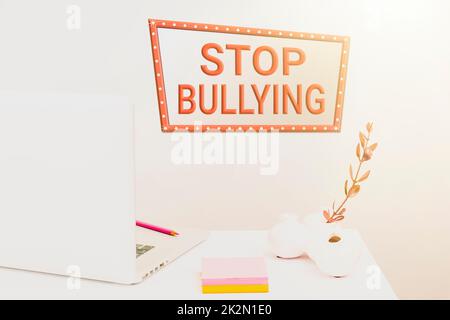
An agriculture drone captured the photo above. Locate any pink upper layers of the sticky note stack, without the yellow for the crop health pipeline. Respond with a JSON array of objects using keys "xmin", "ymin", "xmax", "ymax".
[{"xmin": 202, "ymin": 258, "xmax": 268, "ymax": 285}]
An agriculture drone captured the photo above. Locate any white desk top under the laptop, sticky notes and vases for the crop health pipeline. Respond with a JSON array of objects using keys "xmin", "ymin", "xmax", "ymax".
[{"xmin": 0, "ymin": 231, "xmax": 397, "ymax": 300}]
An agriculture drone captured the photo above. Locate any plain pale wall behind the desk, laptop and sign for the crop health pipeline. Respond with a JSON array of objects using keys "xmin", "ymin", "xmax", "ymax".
[{"xmin": 0, "ymin": 0, "xmax": 450, "ymax": 298}]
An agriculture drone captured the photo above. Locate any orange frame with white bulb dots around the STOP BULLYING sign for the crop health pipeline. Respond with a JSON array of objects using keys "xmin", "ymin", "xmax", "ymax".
[{"xmin": 148, "ymin": 19, "xmax": 350, "ymax": 132}]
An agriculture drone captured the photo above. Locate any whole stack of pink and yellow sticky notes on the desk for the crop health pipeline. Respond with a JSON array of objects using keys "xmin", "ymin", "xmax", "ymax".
[{"xmin": 202, "ymin": 258, "xmax": 269, "ymax": 293}]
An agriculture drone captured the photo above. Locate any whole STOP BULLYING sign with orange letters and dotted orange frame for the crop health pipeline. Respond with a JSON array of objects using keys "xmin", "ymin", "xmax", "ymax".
[{"xmin": 149, "ymin": 20, "xmax": 349, "ymax": 132}]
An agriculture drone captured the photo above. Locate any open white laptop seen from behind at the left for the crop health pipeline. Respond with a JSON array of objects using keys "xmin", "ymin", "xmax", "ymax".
[{"xmin": 0, "ymin": 93, "xmax": 206, "ymax": 284}]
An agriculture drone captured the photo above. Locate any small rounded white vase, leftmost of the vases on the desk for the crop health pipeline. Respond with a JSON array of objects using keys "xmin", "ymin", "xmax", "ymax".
[{"xmin": 269, "ymin": 214, "xmax": 308, "ymax": 259}]
